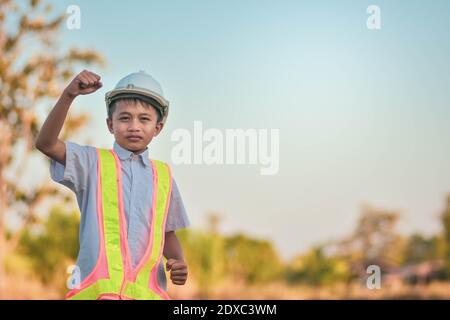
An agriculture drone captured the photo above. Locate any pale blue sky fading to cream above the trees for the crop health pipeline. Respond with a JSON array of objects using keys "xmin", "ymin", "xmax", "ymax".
[{"xmin": 23, "ymin": 0, "xmax": 450, "ymax": 257}]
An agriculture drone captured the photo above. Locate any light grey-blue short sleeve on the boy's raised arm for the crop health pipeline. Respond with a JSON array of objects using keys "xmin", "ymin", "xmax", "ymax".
[{"xmin": 50, "ymin": 141, "xmax": 97, "ymax": 193}]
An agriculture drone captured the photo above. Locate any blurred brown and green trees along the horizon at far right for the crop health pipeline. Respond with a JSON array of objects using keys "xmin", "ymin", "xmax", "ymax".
[{"xmin": 286, "ymin": 196, "xmax": 450, "ymax": 286}]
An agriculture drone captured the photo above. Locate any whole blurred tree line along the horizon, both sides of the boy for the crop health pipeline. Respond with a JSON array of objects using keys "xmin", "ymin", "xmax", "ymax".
[{"xmin": 7, "ymin": 197, "xmax": 450, "ymax": 298}]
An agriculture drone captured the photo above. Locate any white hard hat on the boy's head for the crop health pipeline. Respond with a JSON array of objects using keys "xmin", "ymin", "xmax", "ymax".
[{"xmin": 105, "ymin": 71, "xmax": 169, "ymax": 123}]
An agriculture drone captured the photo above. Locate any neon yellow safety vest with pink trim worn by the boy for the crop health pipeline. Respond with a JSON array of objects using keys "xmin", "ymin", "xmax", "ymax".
[{"xmin": 66, "ymin": 149, "xmax": 172, "ymax": 300}]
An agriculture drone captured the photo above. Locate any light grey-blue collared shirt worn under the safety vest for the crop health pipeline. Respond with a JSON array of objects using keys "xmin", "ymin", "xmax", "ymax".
[{"xmin": 50, "ymin": 141, "xmax": 190, "ymax": 290}]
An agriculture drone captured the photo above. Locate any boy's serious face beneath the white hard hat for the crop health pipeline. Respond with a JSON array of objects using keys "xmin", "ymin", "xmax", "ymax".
[{"xmin": 106, "ymin": 100, "xmax": 163, "ymax": 153}]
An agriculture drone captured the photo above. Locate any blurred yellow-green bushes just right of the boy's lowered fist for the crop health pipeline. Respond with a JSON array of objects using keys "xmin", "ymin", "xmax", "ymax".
[{"xmin": 177, "ymin": 230, "xmax": 283, "ymax": 295}]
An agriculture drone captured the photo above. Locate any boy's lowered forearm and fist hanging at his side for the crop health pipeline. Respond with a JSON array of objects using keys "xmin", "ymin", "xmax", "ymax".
[{"xmin": 163, "ymin": 231, "xmax": 188, "ymax": 285}]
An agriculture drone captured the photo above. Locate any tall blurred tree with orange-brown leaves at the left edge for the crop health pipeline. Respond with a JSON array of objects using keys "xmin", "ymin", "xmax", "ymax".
[{"xmin": 0, "ymin": 0, "xmax": 102, "ymax": 298}]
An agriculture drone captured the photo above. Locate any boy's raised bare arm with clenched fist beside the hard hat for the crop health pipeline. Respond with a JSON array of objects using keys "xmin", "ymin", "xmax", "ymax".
[{"xmin": 36, "ymin": 70, "xmax": 102, "ymax": 165}]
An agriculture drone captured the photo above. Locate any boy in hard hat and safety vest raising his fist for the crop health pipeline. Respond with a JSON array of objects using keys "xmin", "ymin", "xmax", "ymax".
[{"xmin": 36, "ymin": 70, "xmax": 190, "ymax": 300}]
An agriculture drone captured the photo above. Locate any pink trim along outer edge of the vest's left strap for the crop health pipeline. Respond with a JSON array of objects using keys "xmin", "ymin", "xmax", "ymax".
[{"xmin": 66, "ymin": 149, "xmax": 109, "ymax": 299}]
